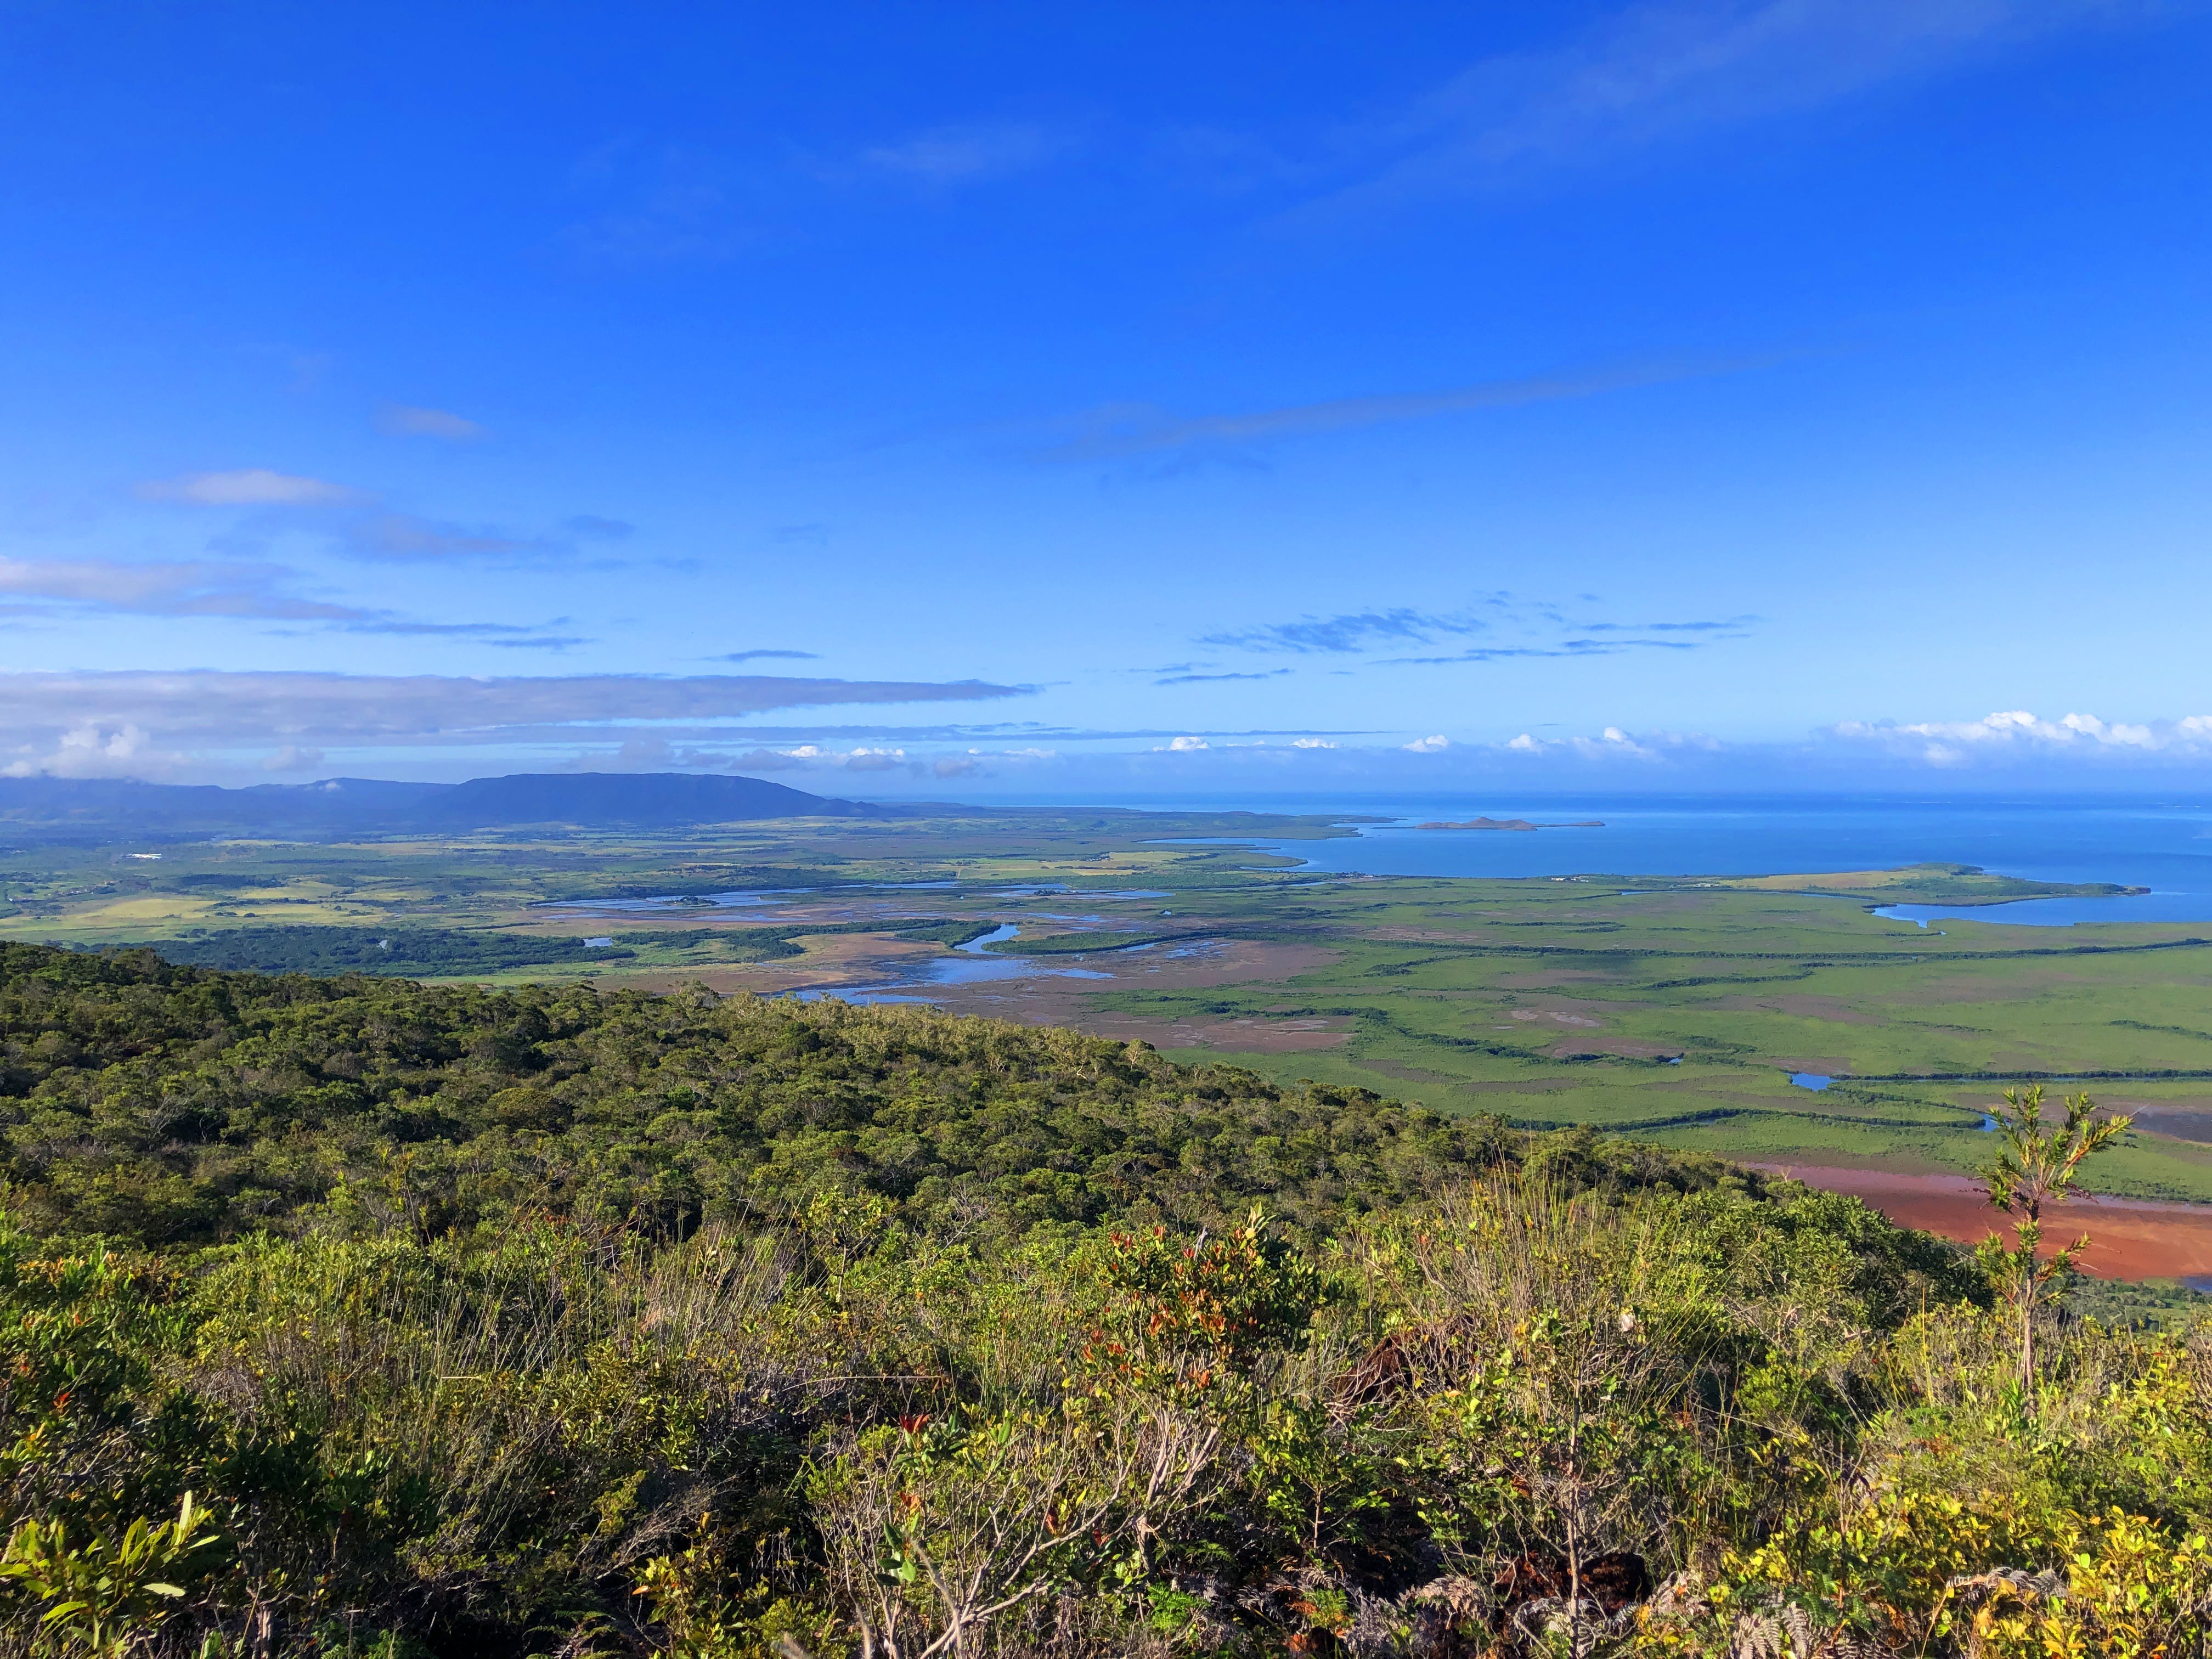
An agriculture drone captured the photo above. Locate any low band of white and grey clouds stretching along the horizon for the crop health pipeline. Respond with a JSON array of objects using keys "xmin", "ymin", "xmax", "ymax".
[{"xmin": 0, "ymin": 668, "xmax": 2212, "ymax": 794}]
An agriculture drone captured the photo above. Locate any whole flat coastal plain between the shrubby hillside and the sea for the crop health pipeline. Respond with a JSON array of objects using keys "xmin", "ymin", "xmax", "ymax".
[{"xmin": 17, "ymin": 810, "xmax": 2212, "ymax": 1201}]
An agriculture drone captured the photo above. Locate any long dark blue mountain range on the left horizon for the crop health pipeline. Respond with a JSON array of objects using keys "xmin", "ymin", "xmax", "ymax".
[{"xmin": 0, "ymin": 772, "xmax": 891, "ymax": 840}]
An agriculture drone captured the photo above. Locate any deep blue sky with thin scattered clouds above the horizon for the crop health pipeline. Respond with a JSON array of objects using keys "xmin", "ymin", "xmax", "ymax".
[{"xmin": 0, "ymin": 0, "xmax": 2212, "ymax": 797}]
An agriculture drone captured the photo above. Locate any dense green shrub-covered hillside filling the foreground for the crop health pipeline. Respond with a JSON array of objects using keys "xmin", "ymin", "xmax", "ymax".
[{"xmin": 0, "ymin": 945, "xmax": 2212, "ymax": 1659}]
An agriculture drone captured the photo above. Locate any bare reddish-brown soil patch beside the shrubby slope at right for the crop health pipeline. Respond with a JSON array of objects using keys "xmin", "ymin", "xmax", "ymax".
[{"xmin": 1763, "ymin": 1164, "xmax": 2212, "ymax": 1278}]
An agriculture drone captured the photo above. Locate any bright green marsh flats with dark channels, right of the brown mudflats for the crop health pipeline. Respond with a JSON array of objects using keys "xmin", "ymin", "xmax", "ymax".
[{"xmin": 1095, "ymin": 878, "xmax": 2212, "ymax": 1197}]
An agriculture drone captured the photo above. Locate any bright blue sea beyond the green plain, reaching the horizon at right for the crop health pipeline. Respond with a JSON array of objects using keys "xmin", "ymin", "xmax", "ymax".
[{"xmin": 1126, "ymin": 794, "xmax": 2212, "ymax": 927}]
